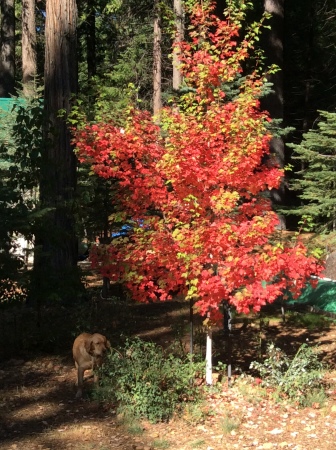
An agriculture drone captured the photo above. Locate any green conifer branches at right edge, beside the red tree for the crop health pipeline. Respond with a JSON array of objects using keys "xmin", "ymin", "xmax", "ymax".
[{"xmin": 289, "ymin": 111, "xmax": 336, "ymax": 232}]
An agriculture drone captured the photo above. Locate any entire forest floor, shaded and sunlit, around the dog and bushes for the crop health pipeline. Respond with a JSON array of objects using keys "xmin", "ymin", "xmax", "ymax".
[{"xmin": 0, "ymin": 262, "xmax": 336, "ymax": 450}]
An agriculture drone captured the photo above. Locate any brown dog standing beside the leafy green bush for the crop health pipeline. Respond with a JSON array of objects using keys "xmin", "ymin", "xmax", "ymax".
[{"xmin": 72, "ymin": 333, "xmax": 111, "ymax": 398}]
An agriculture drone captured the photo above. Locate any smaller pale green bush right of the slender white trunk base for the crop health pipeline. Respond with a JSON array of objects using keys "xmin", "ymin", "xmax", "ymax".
[{"xmin": 250, "ymin": 343, "xmax": 325, "ymax": 406}]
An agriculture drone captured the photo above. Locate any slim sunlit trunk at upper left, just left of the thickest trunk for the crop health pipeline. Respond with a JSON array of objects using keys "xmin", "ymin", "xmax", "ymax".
[{"xmin": 22, "ymin": 0, "xmax": 36, "ymax": 97}]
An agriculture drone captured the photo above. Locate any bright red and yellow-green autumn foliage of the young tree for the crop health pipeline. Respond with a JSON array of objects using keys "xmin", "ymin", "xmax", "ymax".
[{"xmin": 74, "ymin": 1, "xmax": 320, "ymax": 320}]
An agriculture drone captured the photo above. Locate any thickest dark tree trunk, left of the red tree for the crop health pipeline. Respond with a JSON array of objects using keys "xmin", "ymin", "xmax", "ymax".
[{"xmin": 34, "ymin": 0, "xmax": 78, "ymax": 299}]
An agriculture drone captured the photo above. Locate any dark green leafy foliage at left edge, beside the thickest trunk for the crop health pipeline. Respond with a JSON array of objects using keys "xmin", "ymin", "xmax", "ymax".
[{"xmin": 0, "ymin": 93, "xmax": 43, "ymax": 300}]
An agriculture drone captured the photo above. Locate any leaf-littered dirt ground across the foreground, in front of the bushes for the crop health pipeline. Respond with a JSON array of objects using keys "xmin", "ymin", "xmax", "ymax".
[{"xmin": 0, "ymin": 342, "xmax": 336, "ymax": 450}]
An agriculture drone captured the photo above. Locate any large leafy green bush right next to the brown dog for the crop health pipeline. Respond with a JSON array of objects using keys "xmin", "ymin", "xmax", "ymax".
[{"xmin": 95, "ymin": 338, "xmax": 204, "ymax": 422}]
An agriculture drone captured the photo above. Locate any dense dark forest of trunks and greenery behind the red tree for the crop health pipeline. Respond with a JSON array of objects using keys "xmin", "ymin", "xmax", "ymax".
[{"xmin": 0, "ymin": 0, "xmax": 336, "ymax": 302}]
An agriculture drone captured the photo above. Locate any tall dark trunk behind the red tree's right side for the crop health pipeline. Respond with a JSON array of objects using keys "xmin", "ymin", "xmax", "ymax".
[{"xmin": 262, "ymin": 0, "xmax": 285, "ymax": 228}]
